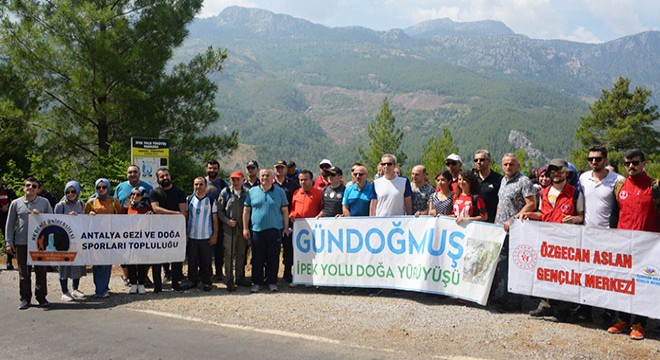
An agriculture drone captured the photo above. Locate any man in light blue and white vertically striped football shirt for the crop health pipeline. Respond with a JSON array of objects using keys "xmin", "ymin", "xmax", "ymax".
[{"xmin": 187, "ymin": 176, "xmax": 219, "ymax": 291}]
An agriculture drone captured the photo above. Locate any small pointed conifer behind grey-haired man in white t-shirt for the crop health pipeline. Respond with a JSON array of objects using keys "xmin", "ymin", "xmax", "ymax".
[{"xmin": 358, "ymin": 98, "xmax": 408, "ymax": 175}]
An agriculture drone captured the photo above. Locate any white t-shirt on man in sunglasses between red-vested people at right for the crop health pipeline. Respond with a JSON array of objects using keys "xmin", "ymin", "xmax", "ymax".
[{"xmin": 580, "ymin": 171, "xmax": 624, "ymax": 228}]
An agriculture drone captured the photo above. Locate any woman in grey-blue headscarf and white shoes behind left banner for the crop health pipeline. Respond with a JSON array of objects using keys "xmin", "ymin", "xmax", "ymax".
[{"xmin": 54, "ymin": 181, "xmax": 87, "ymax": 302}]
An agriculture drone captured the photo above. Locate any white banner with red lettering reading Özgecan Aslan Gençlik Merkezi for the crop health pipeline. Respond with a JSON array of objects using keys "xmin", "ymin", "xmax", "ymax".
[{"xmin": 509, "ymin": 221, "xmax": 660, "ymax": 319}]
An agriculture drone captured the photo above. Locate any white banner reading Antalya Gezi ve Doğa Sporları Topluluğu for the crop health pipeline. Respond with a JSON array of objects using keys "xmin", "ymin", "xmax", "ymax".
[{"xmin": 28, "ymin": 214, "xmax": 186, "ymax": 265}]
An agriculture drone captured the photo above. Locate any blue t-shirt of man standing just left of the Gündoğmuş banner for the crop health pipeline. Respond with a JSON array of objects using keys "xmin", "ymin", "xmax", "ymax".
[{"xmin": 244, "ymin": 185, "xmax": 289, "ymax": 231}]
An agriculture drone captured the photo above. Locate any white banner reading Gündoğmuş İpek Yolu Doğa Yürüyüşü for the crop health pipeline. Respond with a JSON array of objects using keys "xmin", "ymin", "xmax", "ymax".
[{"xmin": 292, "ymin": 216, "xmax": 506, "ymax": 305}]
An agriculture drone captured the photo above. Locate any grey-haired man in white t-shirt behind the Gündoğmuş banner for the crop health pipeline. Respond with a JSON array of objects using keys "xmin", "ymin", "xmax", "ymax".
[{"xmin": 369, "ymin": 154, "xmax": 412, "ymax": 216}]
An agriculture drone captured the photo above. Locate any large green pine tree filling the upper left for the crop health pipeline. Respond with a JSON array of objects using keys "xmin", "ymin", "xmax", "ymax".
[{"xmin": 0, "ymin": 0, "xmax": 238, "ymax": 190}]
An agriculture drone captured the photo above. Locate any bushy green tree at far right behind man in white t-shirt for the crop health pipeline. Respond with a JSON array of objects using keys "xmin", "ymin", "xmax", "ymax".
[{"xmin": 572, "ymin": 77, "xmax": 660, "ymax": 169}]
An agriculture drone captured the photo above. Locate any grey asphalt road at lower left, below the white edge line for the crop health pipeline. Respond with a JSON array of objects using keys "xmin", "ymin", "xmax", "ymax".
[{"xmin": 0, "ymin": 275, "xmax": 394, "ymax": 359}]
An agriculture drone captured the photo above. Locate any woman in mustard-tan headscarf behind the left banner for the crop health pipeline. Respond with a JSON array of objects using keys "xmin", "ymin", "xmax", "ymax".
[{"xmin": 84, "ymin": 178, "xmax": 121, "ymax": 299}]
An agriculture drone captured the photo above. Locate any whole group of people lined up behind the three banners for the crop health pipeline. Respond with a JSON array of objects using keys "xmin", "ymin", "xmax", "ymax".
[{"xmin": 0, "ymin": 146, "xmax": 660, "ymax": 339}]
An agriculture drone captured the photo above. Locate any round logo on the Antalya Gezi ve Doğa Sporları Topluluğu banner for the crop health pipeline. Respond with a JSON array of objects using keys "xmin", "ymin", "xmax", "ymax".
[{"xmin": 30, "ymin": 219, "xmax": 78, "ymax": 263}]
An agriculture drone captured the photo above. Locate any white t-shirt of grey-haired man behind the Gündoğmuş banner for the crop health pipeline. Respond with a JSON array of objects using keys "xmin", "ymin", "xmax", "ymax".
[{"xmin": 374, "ymin": 176, "xmax": 412, "ymax": 216}]
